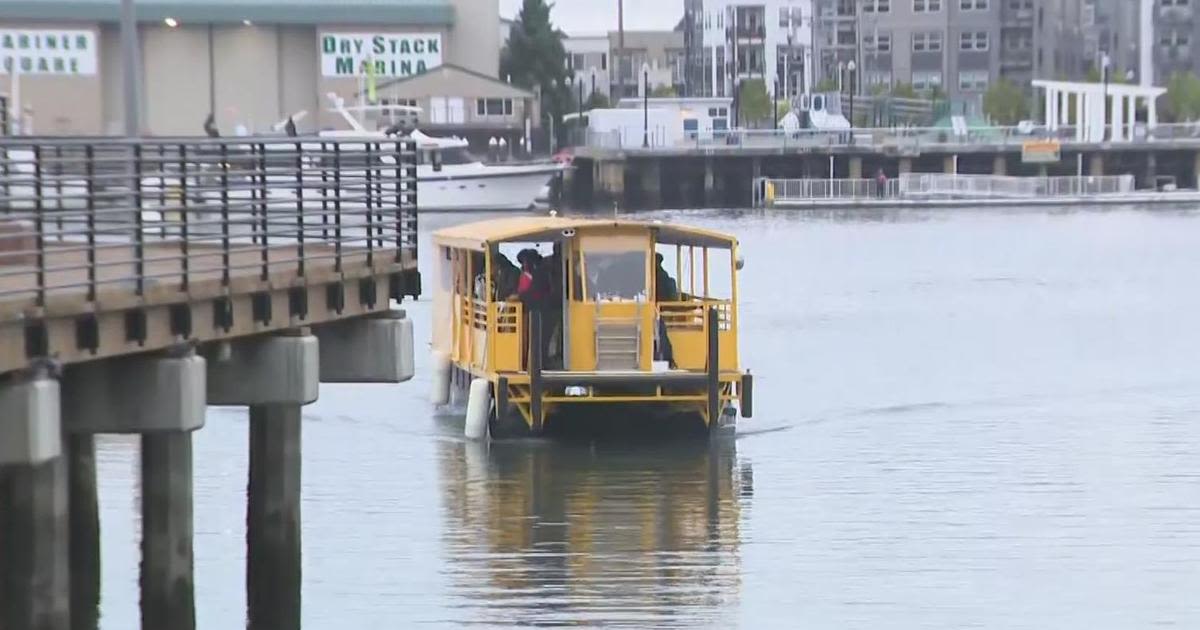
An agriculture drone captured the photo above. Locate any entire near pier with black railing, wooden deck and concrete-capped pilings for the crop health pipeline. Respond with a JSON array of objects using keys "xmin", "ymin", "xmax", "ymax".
[{"xmin": 0, "ymin": 138, "xmax": 420, "ymax": 630}]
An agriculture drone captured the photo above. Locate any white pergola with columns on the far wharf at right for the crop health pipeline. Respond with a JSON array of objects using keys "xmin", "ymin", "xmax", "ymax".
[{"xmin": 1033, "ymin": 79, "xmax": 1166, "ymax": 143}]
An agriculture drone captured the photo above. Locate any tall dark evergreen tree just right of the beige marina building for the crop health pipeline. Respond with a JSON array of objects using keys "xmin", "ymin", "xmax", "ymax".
[{"xmin": 500, "ymin": 0, "xmax": 575, "ymax": 146}]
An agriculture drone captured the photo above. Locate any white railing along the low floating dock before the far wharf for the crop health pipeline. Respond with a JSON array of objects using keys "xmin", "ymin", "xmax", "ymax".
[{"xmin": 754, "ymin": 173, "xmax": 1135, "ymax": 205}]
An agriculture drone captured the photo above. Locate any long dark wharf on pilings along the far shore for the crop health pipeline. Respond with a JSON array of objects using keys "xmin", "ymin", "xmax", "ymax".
[{"xmin": 566, "ymin": 124, "xmax": 1200, "ymax": 210}]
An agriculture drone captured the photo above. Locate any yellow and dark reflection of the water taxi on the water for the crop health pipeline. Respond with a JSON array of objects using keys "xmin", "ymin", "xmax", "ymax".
[{"xmin": 439, "ymin": 439, "xmax": 754, "ymax": 626}]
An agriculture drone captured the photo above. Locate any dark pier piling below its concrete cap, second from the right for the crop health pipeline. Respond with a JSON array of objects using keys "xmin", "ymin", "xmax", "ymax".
[{"xmin": 140, "ymin": 431, "xmax": 196, "ymax": 630}]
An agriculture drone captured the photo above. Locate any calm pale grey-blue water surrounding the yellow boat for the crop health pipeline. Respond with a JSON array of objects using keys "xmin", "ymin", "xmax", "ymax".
[{"xmin": 93, "ymin": 205, "xmax": 1200, "ymax": 630}]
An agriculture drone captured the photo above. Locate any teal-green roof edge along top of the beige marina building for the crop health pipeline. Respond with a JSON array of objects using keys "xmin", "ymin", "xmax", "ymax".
[{"xmin": 0, "ymin": 0, "xmax": 455, "ymax": 26}]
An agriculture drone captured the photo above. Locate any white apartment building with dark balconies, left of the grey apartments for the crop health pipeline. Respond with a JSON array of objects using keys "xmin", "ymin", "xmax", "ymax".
[{"xmin": 680, "ymin": 0, "xmax": 816, "ymax": 97}]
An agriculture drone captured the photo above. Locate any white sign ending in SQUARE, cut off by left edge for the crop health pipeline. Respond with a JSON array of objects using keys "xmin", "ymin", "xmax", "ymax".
[{"xmin": 0, "ymin": 26, "xmax": 96, "ymax": 76}]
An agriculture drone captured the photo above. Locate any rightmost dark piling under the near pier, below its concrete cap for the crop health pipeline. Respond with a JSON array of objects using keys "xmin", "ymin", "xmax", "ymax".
[{"xmin": 246, "ymin": 404, "xmax": 301, "ymax": 630}]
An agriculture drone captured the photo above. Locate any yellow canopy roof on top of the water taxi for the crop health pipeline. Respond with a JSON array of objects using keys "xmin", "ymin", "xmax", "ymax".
[{"xmin": 433, "ymin": 216, "xmax": 737, "ymax": 252}]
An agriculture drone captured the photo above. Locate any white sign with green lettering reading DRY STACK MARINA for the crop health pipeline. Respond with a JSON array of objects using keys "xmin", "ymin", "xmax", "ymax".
[{"xmin": 320, "ymin": 32, "xmax": 442, "ymax": 77}]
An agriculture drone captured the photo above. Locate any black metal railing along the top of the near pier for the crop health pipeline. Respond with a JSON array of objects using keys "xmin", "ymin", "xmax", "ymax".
[{"xmin": 0, "ymin": 138, "xmax": 418, "ymax": 323}]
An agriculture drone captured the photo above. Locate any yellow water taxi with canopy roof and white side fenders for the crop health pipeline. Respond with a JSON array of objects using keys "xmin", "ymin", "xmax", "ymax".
[{"xmin": 431, "ymin": 216, "xmax": 752, "ymax": 439}]
